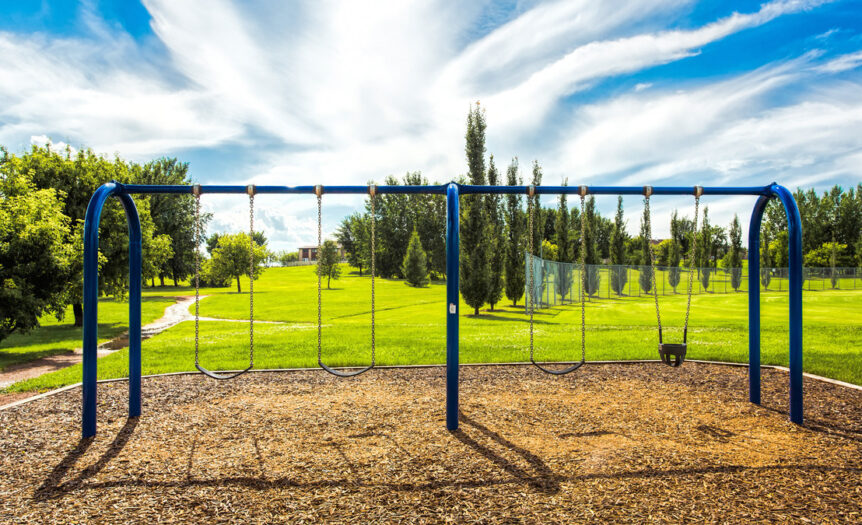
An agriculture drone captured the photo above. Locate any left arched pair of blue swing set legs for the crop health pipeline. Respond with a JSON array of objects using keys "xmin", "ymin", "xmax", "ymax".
[{"xmin": 81, "ymin": 183, "xmax": 141, "ymax": 438}]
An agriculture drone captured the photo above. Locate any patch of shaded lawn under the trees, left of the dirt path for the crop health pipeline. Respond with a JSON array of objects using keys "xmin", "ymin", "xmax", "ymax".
[{"xmin": 0, "ymin": 297, "xmax": 174, "ymax": 371}]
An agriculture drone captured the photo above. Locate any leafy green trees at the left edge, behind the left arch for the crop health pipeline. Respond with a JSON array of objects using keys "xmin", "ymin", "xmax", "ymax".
[{"xmin": 0, "ymin": 144, "xmax": 270, "ymax": 340}]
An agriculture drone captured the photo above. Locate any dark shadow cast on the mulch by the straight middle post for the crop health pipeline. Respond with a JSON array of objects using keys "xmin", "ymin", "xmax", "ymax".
[{"xmin": 451, "ymin": 411, "xmax": 562, "ymax": 494}]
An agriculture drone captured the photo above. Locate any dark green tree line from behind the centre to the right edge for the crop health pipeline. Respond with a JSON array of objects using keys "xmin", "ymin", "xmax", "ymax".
[{"xmin": 337, "ymin": 103, "xmax": 862, "ymax": 314}]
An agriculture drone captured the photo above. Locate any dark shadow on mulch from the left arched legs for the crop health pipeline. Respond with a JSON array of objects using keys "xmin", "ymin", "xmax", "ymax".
[{"xmin": 33, "ymin": 417, "xmax": 138, "ymax": 501}]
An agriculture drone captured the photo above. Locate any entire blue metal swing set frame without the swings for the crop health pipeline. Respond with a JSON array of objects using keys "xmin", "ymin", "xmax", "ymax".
[{"xmin": 82, "ymin": 182, "xmax": 802, "ymax": 438}]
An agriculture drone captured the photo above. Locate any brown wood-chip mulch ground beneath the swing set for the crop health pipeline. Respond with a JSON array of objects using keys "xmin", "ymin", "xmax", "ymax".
[{"xmin": 0, "ymin": 363, "xmax": 862, "ymax": 523}]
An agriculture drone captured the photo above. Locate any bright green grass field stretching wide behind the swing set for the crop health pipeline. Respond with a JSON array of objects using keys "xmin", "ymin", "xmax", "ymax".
[{"xmin": 0, "ymin": 266, "xmax": 862, "ymax": 391}]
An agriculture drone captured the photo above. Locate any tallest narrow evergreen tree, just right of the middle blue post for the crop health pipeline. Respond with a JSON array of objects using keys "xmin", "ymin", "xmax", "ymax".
[{"xmin": 461, "ymin": 102, "xmax": 490, "ymax": 315}]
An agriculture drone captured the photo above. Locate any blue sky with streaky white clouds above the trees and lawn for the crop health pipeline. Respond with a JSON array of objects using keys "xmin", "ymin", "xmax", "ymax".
[{"xmin": 0, "ymin": 0, "xmax": 862, "ymax": 249}]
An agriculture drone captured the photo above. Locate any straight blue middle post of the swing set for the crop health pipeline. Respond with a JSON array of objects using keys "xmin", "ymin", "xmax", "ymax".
[{"xmin": 446, "ymin": 183, "xmax": 461, "ymax": 430}]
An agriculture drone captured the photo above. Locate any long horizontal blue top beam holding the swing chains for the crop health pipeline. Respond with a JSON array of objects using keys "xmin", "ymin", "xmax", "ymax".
[{"xmin": 117, "ymin": 184, "xmax": 771, "ymax": 196}]
